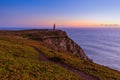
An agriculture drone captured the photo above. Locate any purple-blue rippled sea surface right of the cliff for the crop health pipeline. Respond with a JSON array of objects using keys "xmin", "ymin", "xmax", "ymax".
[{"xmin": 62, "ymin": 28, "xmax": 120, "ymax": 71}]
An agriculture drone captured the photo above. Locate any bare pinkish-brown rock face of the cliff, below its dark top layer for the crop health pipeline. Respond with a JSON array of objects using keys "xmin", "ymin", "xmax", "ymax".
[{"xmin": 43, "ymin": 37, "xmax": 90, "ymax": 60}]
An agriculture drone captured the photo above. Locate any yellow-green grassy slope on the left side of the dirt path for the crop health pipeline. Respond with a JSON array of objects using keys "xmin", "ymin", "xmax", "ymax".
[{"xmin": 0, "ymin": 37, "xmax": 83, "ymax": 80}]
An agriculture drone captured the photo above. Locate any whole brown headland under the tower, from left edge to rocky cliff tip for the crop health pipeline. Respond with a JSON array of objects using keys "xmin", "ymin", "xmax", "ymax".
[{"xmin": 0, "ymin": 29, "xmax": 91, "ymax": 61}]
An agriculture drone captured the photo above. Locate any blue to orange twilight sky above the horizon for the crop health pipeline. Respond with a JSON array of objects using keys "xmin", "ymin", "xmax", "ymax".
[{"xmin": 0, "ymin": 0, "xmax": 120, "ymax": 28}]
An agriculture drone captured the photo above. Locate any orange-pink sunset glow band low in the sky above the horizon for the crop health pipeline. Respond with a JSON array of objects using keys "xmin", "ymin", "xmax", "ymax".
[{"xmin": 9, "ymin": 20, "xmax": 120, "ymax": 28}]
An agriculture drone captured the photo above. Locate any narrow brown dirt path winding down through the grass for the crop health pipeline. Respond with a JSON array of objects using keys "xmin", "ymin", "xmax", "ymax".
[{"xmin": 34, "ymin": 47, "xmax": 99, "ymax": 80}]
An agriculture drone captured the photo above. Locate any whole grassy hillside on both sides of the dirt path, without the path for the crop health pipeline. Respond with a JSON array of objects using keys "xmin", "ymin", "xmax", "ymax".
[{"xmin": 0, "ymin": 31, "xmax": 120, "ymax": 80}]
